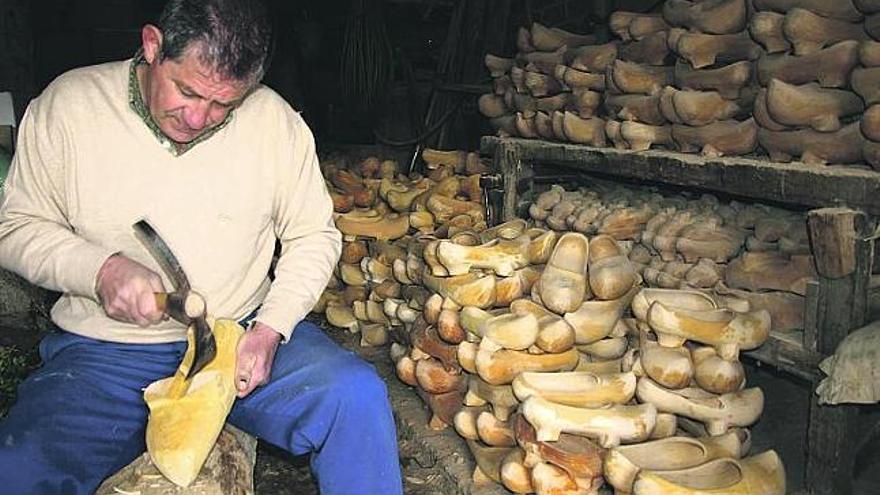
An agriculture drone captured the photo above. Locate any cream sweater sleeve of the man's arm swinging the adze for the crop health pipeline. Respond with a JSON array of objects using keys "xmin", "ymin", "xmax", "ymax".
[{"xmin": 0, "ymin": 86, "xmax": 113, "ymax": 299}]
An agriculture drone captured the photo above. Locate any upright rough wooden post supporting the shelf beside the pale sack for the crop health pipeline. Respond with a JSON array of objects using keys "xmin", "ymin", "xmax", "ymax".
[{"xmin": 804, "ymin": 208, "xmax": 873, "ymax": 495}]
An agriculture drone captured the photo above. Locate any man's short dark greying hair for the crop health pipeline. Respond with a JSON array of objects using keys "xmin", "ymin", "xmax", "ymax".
[{"xmin": 158, "ymin": 0, "xmax": 272, "ymax": 83}]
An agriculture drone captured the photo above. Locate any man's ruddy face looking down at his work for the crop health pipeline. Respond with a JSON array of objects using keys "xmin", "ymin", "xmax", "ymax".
[{"xmin": 140, "ymin": 38, "xmax": 251, "ymax": 143}]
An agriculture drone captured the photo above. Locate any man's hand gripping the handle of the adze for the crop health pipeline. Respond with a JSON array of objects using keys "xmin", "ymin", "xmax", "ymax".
[{"xmin": 96, "ymin": 254, "xmax": 165, "ymax": 327}]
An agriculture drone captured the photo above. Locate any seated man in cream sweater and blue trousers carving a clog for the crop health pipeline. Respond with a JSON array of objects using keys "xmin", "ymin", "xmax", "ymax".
[{"xmin": 0, "ymin": 0, "xmax": 401, "ymax": 495}]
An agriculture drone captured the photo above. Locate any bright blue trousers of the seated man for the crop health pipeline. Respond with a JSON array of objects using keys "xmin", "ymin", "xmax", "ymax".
[{"xmin": 0, "ymin": 322, "xmax": 402, "ymax": 495}]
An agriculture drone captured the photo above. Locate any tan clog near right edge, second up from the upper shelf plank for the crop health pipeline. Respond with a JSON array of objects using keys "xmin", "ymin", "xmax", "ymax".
[{"xmin": 766, "ymin": 79, "xmax": 865, "ymax": 132}]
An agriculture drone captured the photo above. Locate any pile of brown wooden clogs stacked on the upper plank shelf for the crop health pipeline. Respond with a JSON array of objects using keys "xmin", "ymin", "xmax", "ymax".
[{"xmin": 479, "ymin": 0, "xmax": 880, "ymax": 168}]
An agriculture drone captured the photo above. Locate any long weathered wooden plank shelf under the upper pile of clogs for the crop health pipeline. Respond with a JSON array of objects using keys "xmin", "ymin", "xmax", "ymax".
[{"xmin": 480, "ymin": 136, "xmax": 880, "ymax": 215}]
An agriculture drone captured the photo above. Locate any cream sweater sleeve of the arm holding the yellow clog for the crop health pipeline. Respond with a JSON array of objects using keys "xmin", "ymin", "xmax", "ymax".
[{"xmin": 256, "ymin": 110, "xmax": 342, "ymax": 342}]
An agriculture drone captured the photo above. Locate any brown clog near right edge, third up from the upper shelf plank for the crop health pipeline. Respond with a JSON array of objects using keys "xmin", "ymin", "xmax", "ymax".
[{"xmin": 756, "ymin": 40, "xmax": 859, "ymax": 88}]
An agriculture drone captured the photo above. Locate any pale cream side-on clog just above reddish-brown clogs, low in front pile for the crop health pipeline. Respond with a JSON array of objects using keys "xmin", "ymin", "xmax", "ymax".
[{"xmin": 521, "ymin": 397, "xmax": 657, "ymax": 448}]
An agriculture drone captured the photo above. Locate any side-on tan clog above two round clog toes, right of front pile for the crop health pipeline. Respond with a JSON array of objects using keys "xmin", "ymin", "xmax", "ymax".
[{"xmin": 648, "ymin": 301, "xmax": 770, "ymax": 361}]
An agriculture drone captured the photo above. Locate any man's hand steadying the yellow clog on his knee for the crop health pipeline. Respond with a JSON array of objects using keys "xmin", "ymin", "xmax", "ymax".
[{"xmin": 235, "ymin": 322, "xmax": 281, "ymax": 398}]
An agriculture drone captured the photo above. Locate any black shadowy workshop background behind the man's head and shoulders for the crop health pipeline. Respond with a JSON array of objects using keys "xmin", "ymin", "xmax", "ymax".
[{"xmin": 0, "ymin": 0, "xmax": 640, "ymax": 149}]
